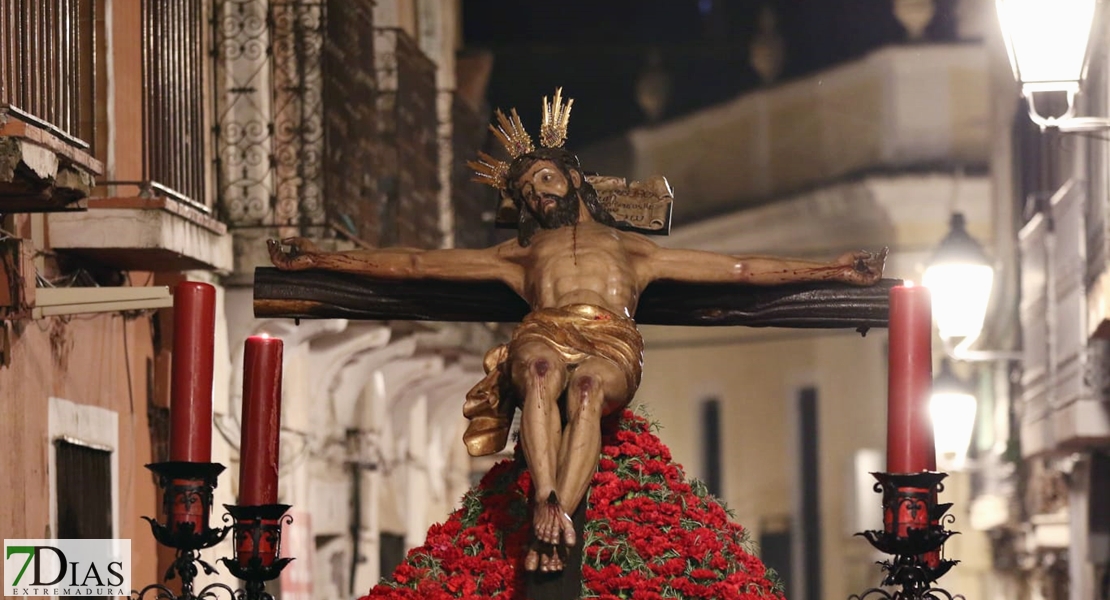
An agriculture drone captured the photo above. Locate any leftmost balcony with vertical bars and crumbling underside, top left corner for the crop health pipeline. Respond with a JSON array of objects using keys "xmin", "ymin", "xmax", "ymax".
[{"xmin": 0, "ymin": 0, "xmax": 103, "ymax": 213}]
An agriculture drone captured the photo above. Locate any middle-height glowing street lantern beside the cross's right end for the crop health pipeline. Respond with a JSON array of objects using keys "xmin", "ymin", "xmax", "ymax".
[{"xmin": 921, "ymin": 213, "xmax": 995, "ymax": 339}]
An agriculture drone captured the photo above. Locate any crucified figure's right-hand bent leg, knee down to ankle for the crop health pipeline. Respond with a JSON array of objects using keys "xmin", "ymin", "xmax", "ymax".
[{"xmin": 556, "ymin": 358, "xmax": 629, "ymax": 536}]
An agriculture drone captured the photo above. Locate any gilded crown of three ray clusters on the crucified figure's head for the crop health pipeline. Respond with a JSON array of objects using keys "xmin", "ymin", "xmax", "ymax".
[{"xmin": 466, "ymin": 88, "xmax": 574, "ymax": 190}]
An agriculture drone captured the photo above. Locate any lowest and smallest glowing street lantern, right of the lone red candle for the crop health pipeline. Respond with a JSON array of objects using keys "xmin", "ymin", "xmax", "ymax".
[{"xmin": 929, "ymin": 359, "xmax": 977, "ymax": 470}]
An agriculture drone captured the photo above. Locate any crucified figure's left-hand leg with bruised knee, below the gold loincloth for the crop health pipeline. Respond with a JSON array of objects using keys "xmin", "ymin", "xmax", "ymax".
[{"xmin": 512, "ymin": 343, "xmax": 569, "ymax": 567}]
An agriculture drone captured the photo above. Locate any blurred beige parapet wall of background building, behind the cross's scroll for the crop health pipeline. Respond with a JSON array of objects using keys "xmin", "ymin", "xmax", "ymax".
[{"xmin": 582, "ymin": 44, "xmax": 990, "ymax": 224}]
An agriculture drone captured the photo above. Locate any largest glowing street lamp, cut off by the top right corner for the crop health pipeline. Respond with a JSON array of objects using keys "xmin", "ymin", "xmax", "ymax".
[{"xmin": 997, "ymin": 0, "xmax": 1110, "ymax": 131}]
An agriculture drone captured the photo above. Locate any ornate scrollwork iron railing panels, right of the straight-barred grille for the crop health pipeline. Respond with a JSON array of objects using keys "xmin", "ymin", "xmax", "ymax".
[{"xmin": 212, "ymin": 0, "xmax": 326, "ymax": 233}]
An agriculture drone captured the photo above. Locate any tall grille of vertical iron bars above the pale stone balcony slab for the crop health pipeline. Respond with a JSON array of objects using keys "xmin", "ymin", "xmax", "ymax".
[{"xmin": 142, "ymin": 0, "xmax": 206, "ymax": 211}]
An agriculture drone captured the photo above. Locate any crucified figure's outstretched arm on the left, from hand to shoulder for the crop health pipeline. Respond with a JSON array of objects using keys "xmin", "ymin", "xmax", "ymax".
[{"xmin": 266, "ymin": 237, "xmax": 522, "ymax": 285}]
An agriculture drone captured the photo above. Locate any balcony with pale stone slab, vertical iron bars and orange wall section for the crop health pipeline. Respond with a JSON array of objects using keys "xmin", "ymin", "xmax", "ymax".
[{"xmin": 49, "ymin": 0, "xmax": 233, "ymax": 272}]
